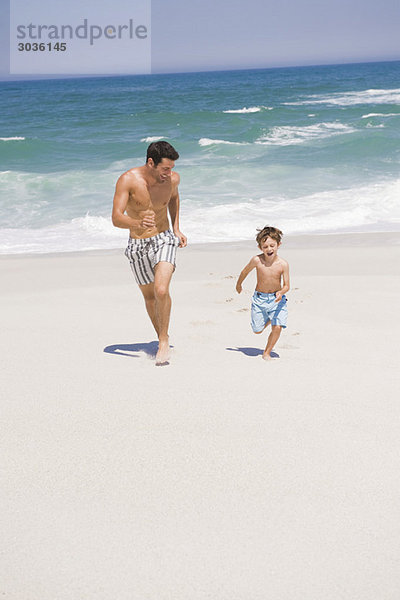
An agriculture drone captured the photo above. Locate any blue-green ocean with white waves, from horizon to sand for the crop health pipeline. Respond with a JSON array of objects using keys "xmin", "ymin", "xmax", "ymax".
[{"xmin": 0, "ymin": 62, "xmax": 400, "ymax": 254}]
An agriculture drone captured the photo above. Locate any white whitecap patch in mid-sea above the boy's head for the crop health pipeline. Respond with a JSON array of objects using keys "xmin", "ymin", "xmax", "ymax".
[{"xmin": 255, "ymin": 123, "xmax": 355, "ymax": 146}]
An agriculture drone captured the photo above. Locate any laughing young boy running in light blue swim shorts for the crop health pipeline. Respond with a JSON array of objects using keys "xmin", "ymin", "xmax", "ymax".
[{"xmin": 236, "ymin": 226, "xmax": 290, "ymax": 360}]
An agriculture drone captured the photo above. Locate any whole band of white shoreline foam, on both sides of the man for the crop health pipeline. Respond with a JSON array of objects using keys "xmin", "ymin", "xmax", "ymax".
[{"xmin": 0, "ymin": 179, "xmax": 400, "ymax": 254}]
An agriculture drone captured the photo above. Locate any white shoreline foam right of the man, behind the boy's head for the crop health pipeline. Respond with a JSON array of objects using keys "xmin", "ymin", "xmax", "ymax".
[{"xmin": 181, "ymin": 179, "xmax": 400, "ymax": 242}]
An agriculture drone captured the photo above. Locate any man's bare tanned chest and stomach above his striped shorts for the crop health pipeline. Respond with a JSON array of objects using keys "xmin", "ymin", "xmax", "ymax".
[{"xmin": 124, "ymin": 167, "xmax": 179, "ymax": 239}]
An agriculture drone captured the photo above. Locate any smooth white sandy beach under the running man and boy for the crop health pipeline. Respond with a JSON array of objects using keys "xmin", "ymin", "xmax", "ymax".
[{"xmin": 0, "ymin": 233, "xmax": 400, "ymax": 600}]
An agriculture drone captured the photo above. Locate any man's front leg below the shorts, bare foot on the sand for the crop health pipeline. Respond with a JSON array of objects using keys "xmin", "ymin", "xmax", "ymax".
[{"xmin": 154, "ymin": 261, "xmax": 174, "ymax": 364}]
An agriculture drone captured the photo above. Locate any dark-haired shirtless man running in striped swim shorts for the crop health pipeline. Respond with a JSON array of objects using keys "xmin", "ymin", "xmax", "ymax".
[{"xmin": 112, "ymin": 141, "xmax": 187, "ymax": 365}]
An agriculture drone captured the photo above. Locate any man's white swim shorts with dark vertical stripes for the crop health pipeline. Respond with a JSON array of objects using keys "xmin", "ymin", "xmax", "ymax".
[{"xmin": 125, "ymin": 229, "xmax": 180, "ymax": 285}]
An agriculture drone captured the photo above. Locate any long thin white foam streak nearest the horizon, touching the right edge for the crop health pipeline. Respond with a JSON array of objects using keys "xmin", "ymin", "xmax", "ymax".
[{"xmin": 283, "ymin": 88, "xmax": 400, "ymax": 106}]
